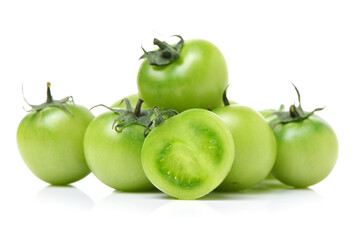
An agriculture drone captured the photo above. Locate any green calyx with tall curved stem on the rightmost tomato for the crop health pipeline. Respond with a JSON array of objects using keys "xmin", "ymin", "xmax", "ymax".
[{"xmin": 269, "ymin": 84, "xmax": 325, "ymax": 128}]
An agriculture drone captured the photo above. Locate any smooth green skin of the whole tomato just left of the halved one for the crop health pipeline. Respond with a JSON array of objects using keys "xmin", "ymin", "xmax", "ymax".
[{"xmin": 84, "ymin": 112, "xmax": 154, "ymax": 191}]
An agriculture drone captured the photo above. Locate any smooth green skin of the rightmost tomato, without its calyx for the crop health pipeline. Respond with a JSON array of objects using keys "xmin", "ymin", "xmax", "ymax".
[{"xmin": 272, "ymin": 115, "xmax": 338, "ymax": 188}]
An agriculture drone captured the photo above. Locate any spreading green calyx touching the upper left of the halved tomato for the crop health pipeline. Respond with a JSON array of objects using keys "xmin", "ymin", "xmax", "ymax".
[{"xmin": 91, "ymin": 98, "xmax": 153, "ymax": 132}]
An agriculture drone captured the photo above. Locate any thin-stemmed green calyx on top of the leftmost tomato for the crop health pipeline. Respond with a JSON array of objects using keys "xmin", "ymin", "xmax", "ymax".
[{"xmin": 23, "ymin": 82, "xmax": 74, "ymax": 117}]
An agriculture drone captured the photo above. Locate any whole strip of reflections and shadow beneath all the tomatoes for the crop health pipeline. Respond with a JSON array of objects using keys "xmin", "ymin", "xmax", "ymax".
[{"xmin": 26, "ymin": 180, "xmax": 322, "ymax": 218}]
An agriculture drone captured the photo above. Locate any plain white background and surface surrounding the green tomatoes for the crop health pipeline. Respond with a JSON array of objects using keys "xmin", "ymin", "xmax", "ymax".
[{"xmin": 0, "ymin": 0, "xmax": 360, "ymax": 239}]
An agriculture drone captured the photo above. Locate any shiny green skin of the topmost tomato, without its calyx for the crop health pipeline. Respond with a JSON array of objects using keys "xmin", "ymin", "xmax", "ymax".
[{"xmin": 137, "ymin": 40, "xmax": 228, "ymax": 112}]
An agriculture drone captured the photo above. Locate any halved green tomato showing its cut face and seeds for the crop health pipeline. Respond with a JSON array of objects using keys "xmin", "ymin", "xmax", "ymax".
[{"xmin": 141, "ymin": 109, "xmax": 234, "ymax": 199}]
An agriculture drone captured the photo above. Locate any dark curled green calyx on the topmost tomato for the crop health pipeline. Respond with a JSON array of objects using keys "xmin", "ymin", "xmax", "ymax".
[{"xmin": 140, "ymin": 35, "xmax": 184, "ymax": 66}]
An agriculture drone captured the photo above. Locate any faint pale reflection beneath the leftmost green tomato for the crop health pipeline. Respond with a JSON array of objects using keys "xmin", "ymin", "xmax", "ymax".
[{"xmin": 32, "ymin": 186, "xmax": 94, "ymax": 212}]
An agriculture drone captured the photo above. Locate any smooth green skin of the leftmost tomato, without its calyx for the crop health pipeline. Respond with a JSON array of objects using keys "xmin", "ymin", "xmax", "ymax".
[{"xmin": 17, "ymin": 104, "xmax": 94, "ymax": 185}]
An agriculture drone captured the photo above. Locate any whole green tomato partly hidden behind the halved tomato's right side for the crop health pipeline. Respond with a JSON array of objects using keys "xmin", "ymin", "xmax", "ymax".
[{"xmin": 213, "ymin": 105, "xmax": 276, "ymax": 191}]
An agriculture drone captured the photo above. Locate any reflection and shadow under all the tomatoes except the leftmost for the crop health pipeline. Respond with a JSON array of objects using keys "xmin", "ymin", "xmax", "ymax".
[{"xmin": 92, "ymin": 180, "xmax": 322, "ymax": 218}]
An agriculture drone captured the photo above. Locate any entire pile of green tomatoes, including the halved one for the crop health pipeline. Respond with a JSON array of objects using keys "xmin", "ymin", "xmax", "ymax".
[{"xmin": 17, "ymin": 36, "xmax": 338, "ymax": 199}]
